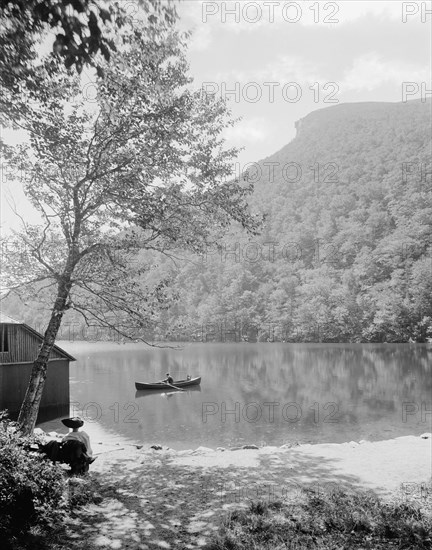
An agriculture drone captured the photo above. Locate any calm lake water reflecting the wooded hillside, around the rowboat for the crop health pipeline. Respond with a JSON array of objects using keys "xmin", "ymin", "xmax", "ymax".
[{"xmin": 41, "ymin": 342, "xmax": 432, "ymax": 450}]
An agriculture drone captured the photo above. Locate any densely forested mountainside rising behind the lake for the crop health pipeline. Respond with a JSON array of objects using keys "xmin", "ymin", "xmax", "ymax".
[{"xmin": 4, "ymin": 97, "xmax": 432, "ymax": 342}]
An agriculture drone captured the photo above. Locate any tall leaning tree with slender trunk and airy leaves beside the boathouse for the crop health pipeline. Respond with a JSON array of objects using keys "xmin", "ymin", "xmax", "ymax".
[{"xmin": 2, "ymin": 10, "xmax": 258, "ymax": 430}]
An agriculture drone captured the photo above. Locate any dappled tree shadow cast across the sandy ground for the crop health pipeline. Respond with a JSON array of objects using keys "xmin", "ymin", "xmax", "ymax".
[{"xmin": 59, "ymin": 451, "xmax": 384, "ymax": 550}]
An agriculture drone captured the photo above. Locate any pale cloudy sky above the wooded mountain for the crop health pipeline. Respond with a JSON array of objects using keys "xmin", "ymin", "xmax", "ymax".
[{"xmin": 2, "ymin": 0, "xmax": 432, "ymax": 231}]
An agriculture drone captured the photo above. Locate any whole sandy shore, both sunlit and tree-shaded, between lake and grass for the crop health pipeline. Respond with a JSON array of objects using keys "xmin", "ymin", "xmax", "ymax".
[{"xmin": 38, "ymin": 427, "xmax": 432, "ymax": 550}]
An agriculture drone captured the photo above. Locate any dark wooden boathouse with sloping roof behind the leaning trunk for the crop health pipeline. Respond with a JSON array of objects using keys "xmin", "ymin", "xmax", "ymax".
[{"xmin": 0, "ymin": 312, "xmax": 75, "ymax": 422}]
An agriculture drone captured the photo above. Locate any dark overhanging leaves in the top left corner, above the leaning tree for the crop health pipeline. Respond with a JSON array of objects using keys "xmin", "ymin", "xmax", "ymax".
[{"xmin": 0, "ymin": 0, "xmax": 177, "ymax": 91}]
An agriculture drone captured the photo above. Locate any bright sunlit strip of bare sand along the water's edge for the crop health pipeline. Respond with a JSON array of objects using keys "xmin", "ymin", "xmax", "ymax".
[{"xmin": 39, "ymin": 426, "xmax": 432, "ymax": 496}]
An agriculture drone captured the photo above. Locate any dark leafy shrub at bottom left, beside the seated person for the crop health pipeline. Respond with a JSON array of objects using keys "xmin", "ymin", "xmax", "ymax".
[{"xmin": 0, "ymin": 413, "xmax": 65, "ymax": 541}]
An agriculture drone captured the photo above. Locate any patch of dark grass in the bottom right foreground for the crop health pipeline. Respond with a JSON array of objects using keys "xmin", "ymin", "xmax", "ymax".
[{"xmin": 207, "ymin": 490, "xmax": 432, "ymax": 550}]
